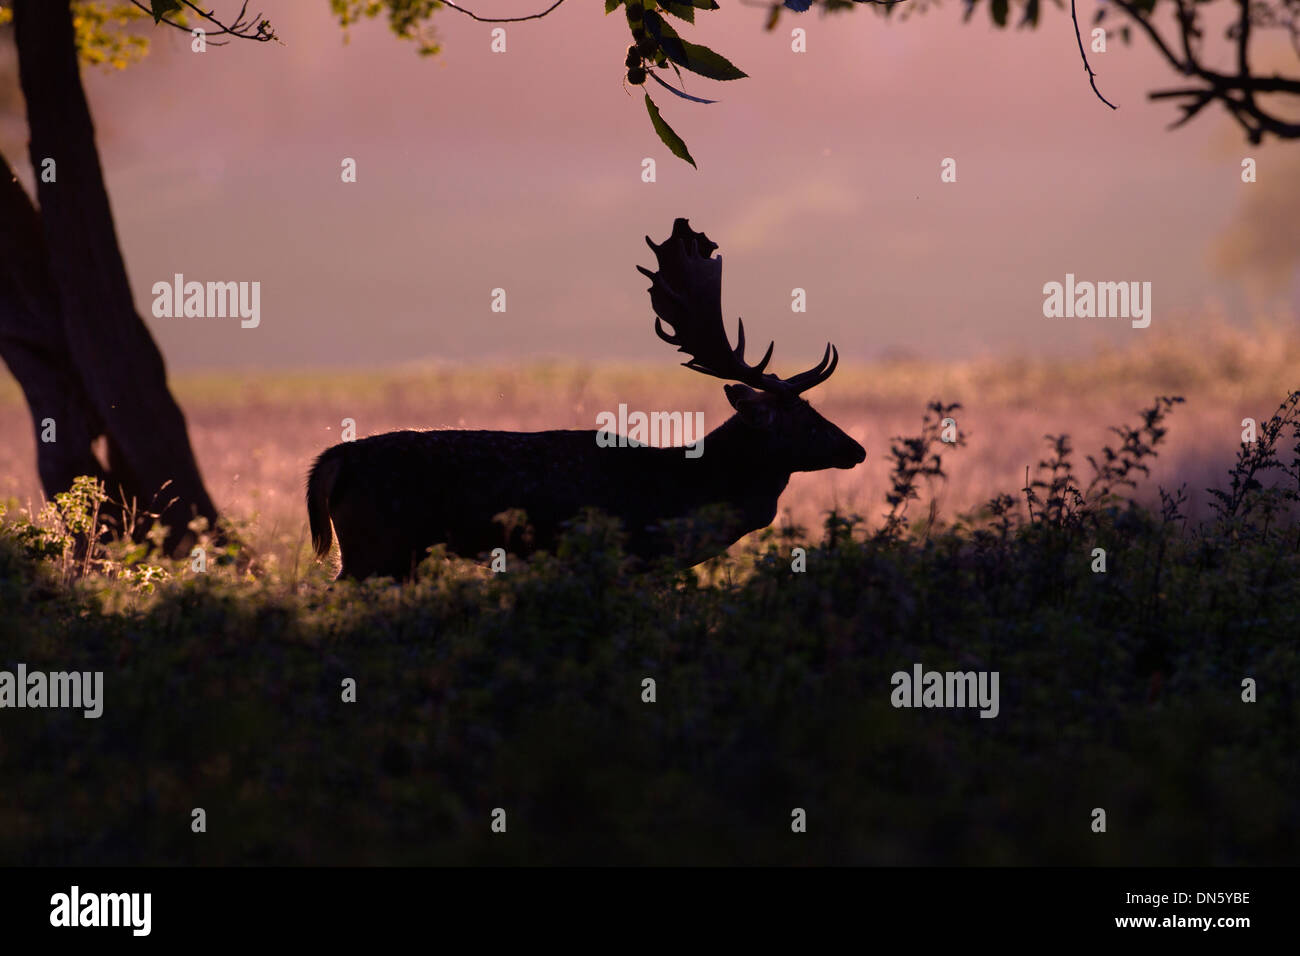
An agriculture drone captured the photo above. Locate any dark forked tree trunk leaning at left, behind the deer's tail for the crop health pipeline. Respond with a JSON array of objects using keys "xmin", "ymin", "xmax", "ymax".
[{"xmin": 0, "ymin": 0, "xmax": 217, "ymax": 553}]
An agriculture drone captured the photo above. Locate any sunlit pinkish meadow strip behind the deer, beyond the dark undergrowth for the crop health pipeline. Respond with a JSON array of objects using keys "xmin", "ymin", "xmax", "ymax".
[{"xmin": 0, "ymin": 314, "xmax": 1300, "ymax": 564}]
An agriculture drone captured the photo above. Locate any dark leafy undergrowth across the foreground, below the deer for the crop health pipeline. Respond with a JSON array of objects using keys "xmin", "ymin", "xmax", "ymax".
[{"xmin": 0, "ymin": 395, "xmax": 1300, "ymax": 865}]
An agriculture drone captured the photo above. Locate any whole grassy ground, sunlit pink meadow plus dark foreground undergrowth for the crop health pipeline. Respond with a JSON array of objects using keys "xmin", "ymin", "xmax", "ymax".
[{"xmin": 0, "ymin": 319, "xmax": 1300, "ymax": 865}]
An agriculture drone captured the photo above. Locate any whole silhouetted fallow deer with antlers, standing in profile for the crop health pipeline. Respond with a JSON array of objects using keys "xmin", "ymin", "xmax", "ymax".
[{"xmin": 307, "ymin": 219, "xmax": 866, "ymax": 579}]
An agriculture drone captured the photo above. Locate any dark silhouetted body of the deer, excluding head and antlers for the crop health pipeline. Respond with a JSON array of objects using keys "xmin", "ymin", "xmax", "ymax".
[{"xmin": 307, "ymin": 416, "xmax": 790, "ymax": 578}]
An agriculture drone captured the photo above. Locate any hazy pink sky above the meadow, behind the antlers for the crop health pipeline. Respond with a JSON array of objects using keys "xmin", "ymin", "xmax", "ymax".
[{"xmin": 12, "ymin": 0, "xmax": 1294, "ymax": 372}]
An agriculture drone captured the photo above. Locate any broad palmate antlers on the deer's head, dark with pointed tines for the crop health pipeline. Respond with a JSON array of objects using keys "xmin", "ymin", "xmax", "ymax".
[{"xmin": 637, "ymin": 219, "xmax": 840, "ymax": 395}]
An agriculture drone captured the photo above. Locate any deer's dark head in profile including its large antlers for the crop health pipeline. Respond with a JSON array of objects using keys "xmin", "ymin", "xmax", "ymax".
[{"xmin": 637, "ymin": 219, "xmax": 867, "ymax": 471}]
